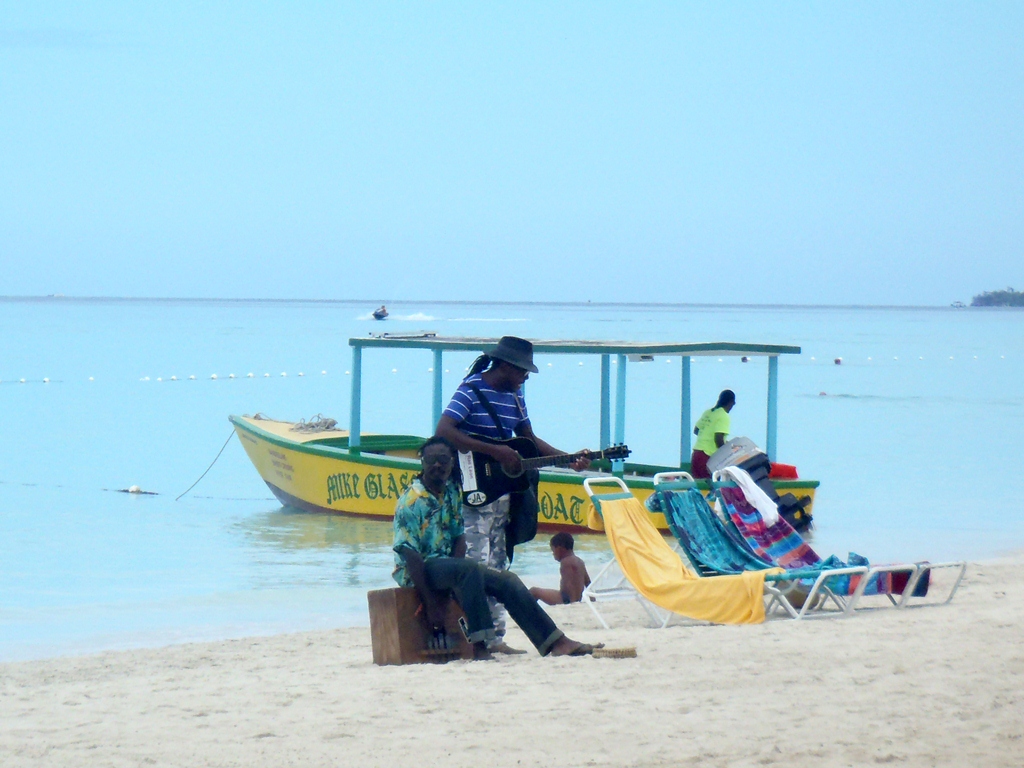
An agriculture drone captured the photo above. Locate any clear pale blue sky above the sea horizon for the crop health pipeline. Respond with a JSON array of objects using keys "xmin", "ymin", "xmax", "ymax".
[{"xmin": 0, "ymin": 0, "xmax": 1024, "ymax": 305}]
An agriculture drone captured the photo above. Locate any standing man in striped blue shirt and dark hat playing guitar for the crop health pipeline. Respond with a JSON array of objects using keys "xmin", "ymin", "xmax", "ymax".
[{"xmin": 434, "ymin": 336, "xmax": 590, "ymax": 653}]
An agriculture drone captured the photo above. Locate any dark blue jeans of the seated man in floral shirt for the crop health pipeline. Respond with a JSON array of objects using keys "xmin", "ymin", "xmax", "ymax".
[{"xmin": 424, "ymin": 557, "xmax": 564, "ymax": 656}]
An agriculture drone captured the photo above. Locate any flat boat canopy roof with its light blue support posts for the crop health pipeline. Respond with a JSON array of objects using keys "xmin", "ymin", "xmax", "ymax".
[{"xmin": 348, "ymin": 333, "xmax": 801, "ymax": 471}]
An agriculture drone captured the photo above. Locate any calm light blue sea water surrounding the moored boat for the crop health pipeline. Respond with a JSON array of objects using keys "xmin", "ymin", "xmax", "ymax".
[{"xmin": 0, "ymin": 298, "xmax": 1024, "ymax": 660}]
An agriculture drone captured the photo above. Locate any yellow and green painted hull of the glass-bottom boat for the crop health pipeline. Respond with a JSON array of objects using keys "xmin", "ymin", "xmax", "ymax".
[{"xmin": 230, "ymin": 416, "xmax": 818, "ymax": 532}]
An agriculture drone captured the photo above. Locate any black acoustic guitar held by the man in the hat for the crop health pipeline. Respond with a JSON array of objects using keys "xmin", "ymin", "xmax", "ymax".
[{"xmin": 459, "ymin": 437, "xmax": 631, "ymax": 507}]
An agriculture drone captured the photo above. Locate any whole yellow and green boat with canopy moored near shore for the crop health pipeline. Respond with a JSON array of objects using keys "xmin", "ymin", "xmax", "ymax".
[{"xmin": 230, "ymin": 334, "xmax": 818, "ymax": 532}]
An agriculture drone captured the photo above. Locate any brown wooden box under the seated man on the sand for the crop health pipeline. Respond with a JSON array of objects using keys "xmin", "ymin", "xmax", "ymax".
[{"xmin": 367, "ymin": 587, "xmax": 473, "ymax": 666}]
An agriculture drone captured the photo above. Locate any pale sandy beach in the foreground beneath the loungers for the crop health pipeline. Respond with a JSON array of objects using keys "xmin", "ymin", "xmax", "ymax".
[{"xmin": 0, "ymin": 559, "xmax": 1024, "ymax": 768}]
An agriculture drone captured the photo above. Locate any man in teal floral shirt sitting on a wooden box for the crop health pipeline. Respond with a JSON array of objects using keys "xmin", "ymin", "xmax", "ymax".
[{"xmin": 393, "ymin": 437, "xmax": 595, "ymax": 658}]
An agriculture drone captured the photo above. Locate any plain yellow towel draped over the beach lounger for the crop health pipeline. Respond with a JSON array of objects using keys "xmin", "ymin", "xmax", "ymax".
[{"xmin": 588, "ymin": 498, "xmax": 774, "ymax": 624}]
